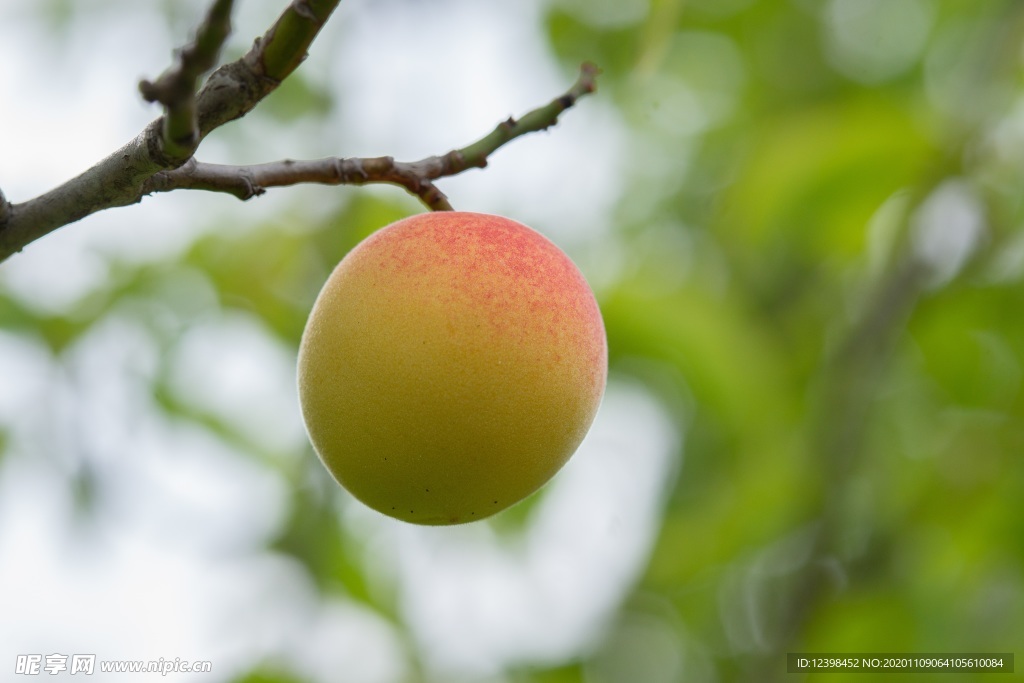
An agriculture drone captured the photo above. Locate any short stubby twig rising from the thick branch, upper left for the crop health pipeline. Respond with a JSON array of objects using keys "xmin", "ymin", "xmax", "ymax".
[{"xmin": 138, "ymin": 0, "xmax": 233, "ymax": 163}]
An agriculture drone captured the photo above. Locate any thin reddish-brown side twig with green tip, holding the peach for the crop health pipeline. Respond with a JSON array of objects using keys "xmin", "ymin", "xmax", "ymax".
[{"xmin": 142, "ymin": 63, "xmax": 599, "ymax": 211}]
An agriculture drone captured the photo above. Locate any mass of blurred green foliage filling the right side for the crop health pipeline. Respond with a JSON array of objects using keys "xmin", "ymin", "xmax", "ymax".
[{"xmin": 561, "ymin": 1, "xmax": 1024, "ymax": 681}]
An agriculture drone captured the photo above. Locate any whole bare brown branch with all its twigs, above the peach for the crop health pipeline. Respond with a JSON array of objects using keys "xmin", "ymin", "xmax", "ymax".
[{"xmin": 0, "ymin": 0, "xmax": 599, "ymax": 261}]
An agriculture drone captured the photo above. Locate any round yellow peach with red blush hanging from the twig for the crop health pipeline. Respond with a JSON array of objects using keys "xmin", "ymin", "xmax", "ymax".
[{"xmin": 298, "ymin": 212, "xmax": 607, "ymax": 524}]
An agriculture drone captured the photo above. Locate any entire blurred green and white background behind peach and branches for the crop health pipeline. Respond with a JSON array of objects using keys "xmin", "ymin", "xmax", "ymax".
[{"xmin": 0, "ymin": 0, "xmax": 1024, "ymax": 683}]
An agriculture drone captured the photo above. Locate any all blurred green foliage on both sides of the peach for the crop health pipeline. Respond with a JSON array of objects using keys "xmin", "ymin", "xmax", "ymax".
[{"xmin": 0, "ymin": 0, "xmax": 1024, "ymax": 683}]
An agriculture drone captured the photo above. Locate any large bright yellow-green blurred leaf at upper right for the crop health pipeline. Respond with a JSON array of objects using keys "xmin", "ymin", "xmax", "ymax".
[{"xmin": 717, "ymin": 93, "xmax": 934, "ymax": 269}]
